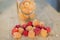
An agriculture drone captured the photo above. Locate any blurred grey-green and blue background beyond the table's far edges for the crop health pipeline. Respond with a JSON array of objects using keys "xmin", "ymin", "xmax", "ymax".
[{"xmin": 0, "ymin": 0, "xmax": 60, "ymax": 12}]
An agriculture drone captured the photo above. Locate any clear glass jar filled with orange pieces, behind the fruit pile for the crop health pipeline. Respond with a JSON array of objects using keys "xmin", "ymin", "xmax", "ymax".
[{"xmin": 17, "ymin": 0, "xmax": 36, "ymax": 24}]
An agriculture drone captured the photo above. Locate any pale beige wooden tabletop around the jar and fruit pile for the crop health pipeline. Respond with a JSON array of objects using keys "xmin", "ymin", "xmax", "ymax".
[{"xmin": 0, "ymin": 0, "xmax": 60, "ymax": 40}]
